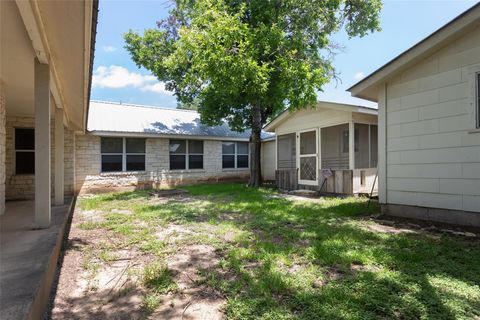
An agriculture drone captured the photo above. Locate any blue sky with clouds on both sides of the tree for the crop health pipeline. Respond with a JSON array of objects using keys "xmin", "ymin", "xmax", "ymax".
[{"xmin": 92, "ymin": 0, "xmax": 477, "ymax": 107}]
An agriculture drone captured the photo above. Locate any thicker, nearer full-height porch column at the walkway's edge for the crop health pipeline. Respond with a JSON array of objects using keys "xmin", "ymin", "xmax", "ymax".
[{"xmin": 34, "ymin": 59, "xmax": 51, "ymax": 228}]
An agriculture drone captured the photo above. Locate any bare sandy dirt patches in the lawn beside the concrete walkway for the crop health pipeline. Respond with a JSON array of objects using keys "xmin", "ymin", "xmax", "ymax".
[{"xmin": 47, "ymin": 199, "xmax": 226, "ymax": 319}]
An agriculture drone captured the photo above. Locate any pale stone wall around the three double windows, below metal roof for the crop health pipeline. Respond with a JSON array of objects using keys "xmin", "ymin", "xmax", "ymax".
[{"xmin": 75, "ymin": 134, "xmax": 249, "ymax": 193}]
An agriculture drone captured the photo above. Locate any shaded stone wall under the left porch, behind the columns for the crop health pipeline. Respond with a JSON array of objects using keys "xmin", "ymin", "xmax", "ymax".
[{"xmin": 5, "ymin": 116, "xmax": 75, "ymax": 200}]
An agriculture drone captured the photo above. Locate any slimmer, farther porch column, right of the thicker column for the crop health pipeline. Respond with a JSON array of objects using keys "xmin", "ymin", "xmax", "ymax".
[{"xmin": 55, "ymin": 108, "xmax": 65, "ymax": 206}]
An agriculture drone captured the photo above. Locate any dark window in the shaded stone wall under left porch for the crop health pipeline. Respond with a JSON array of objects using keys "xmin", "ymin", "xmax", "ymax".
[{"xmin": 15, "ymin": 128, "xmax": 35, "ymax": 174}]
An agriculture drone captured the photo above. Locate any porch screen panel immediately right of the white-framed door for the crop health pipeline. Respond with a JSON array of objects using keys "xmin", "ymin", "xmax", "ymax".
[{"xmin": 320, "ymin": 123, "xmax": 349, "ymax": 169}]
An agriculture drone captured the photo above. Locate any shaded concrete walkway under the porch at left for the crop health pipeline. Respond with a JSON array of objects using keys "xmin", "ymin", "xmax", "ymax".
[{"xmin": 0, "ymin": 198, "xmax": 73, "ymax": 320}]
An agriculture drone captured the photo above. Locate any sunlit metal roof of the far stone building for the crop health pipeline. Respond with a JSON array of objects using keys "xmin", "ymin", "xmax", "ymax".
[{"xmin": 87, "ymin": 101, "xmax": 271, "ymax": 140}]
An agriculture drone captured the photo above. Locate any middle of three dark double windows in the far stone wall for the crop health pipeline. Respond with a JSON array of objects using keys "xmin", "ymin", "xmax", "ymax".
[{"xmin": 170, "ymin": 140, "xmax": 203, "ymax": 170}]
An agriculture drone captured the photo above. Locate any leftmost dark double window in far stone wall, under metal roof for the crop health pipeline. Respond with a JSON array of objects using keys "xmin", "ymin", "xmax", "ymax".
[{"xmin": 101, "ymin": 137, "xmax": 145, "ymax": 172}]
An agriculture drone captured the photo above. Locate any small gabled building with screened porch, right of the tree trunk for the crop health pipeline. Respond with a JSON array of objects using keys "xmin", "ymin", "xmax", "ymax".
[{"xmin": 264, "ymin": 101, "xmax": 377, "ymax": 194}]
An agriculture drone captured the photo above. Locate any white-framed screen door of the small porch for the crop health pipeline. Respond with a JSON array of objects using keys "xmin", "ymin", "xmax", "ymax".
[{"xmin": 297, "ymin": 130, "xmax": 318, "ymax": 185}]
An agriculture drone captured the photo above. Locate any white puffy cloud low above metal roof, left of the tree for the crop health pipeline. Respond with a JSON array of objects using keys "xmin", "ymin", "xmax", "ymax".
[{"xmin": 92, "ymin": 65, "xmax": 173, "ymax": 96}]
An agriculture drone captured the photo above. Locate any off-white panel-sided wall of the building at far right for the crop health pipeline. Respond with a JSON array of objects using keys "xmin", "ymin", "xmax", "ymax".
[{"xmin": 379, "ymin": 27, "xmax": 480, "ymax": 212}]
